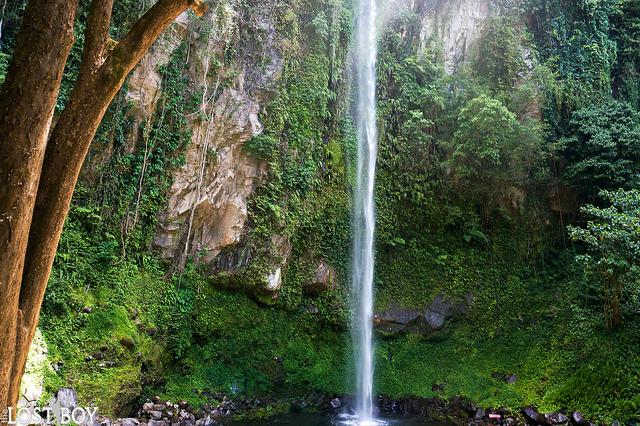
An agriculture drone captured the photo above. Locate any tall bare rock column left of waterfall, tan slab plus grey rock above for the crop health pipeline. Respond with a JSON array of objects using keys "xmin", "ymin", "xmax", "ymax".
[{"xmin": 154, "ymin": 1, "xmax": 282, "ymax": 262}]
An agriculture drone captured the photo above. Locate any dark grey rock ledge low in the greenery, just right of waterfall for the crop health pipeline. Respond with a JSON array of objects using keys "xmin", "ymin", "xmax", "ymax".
[{"xmin": 374, "ymin": 294, "xmax": 473, "ymax": 335}]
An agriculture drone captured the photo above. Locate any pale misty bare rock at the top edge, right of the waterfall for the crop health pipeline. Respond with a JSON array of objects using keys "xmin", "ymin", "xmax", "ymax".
[{"xmin": 420, "ymin": 0, "xmax": 497, "ymax": 74}]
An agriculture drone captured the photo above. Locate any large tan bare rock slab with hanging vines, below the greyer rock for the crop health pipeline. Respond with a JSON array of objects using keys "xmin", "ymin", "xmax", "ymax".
[{"xmin": 154, "ymin": 89, "xmax": 265, "ymax": 261}]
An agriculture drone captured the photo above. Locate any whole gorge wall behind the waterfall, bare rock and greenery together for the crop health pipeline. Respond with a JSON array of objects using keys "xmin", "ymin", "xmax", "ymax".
[{"xmin": 10, "ymin": 0, "xmax": 640, "ymax": 419}]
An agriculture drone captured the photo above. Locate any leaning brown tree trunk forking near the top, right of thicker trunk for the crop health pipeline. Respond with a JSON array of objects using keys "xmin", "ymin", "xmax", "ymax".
[{"xmin": 0, "ymin": 0, "xmax": 203, "ymax": 414}]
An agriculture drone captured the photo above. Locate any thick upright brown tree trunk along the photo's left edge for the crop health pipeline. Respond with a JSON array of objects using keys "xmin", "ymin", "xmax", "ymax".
[{"xmin": 0, "ymin": 0, "xmax": 77, "ymax": 411}]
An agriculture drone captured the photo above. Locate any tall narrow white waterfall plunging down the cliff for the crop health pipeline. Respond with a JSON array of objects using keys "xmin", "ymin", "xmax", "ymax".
[{"xmin": 352, "ymin": 0, "xmax": 378, "ymax": 425}]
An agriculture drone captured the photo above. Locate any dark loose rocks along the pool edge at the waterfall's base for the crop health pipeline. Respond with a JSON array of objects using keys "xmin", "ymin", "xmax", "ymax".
[{"xmin": 41, "ymin": 388, "xmax": 604, "ymax": 426}]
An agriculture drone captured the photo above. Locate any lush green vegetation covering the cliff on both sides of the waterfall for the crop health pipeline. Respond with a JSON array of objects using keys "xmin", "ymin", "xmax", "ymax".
[{"xmin": 0, "ymin": 0, "xmax": 640, "ymax": 420}]
